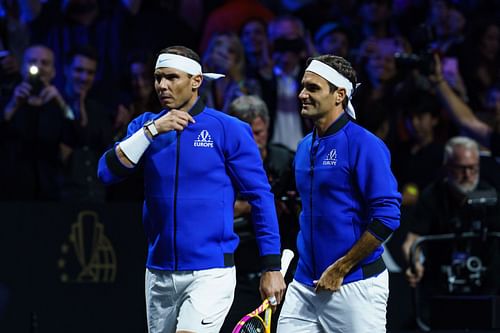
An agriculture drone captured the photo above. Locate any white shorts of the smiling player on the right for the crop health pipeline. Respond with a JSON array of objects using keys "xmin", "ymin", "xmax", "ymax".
[{"xmin": 277, "ymin": 270, "xmax": 389, "ymax": 333}]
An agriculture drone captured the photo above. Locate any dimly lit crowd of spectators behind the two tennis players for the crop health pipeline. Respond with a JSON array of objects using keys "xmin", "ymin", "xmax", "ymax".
[{"xmin": 0, "ymin": 0, "xmax": 500, "ymax": 204}]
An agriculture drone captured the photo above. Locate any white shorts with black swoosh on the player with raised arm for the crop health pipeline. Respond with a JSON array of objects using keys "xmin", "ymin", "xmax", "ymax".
[{"xmin": 146, "ymin": 267, "xmax": 236, "ymax": 333}]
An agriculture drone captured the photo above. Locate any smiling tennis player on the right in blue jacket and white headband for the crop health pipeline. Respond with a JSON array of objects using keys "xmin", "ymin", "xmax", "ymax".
[{"xmin": 278, "ymin": 55, "xmax": 401, "ymax": 333}]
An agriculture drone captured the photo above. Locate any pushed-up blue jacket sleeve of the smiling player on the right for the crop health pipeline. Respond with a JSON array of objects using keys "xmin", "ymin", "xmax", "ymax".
[{"xmin": 352, "ymin": 135, "xmax": 401, "ymax": 241}]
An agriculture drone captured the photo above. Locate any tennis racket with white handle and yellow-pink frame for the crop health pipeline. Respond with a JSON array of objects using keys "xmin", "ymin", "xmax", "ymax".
[{"xmin": 232, "ymin": 249, "xmax": 294, "ymax": 333}]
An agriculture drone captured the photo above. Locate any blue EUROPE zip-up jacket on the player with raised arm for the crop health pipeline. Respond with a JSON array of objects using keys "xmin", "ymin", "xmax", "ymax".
[{"xmin": 98, "ymin": 99, "xmax": 280, "ymax": 271}]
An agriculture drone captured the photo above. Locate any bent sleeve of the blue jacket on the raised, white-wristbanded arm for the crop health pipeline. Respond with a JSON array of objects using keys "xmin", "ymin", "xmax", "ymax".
[{"xmin": 97, "ymin": 115, "xmax": 145, "ymax": 185}]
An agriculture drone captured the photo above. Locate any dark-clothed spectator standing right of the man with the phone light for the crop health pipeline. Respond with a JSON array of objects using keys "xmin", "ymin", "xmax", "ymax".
[{"xmin": 61, "ymin": 46, "xmax": 112, "ymax": 202}]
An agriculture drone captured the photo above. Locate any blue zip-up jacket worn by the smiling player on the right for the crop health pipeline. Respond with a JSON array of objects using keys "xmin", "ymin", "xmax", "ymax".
[{"xmin": 295, "ymin": 113, "xmax": 401, "ymax": 286}]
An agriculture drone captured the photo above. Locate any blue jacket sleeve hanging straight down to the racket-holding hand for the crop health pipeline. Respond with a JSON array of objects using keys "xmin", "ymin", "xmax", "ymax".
[{"xmin": 224, "ymin": 121, "xmax": 281, "ymax": 270}]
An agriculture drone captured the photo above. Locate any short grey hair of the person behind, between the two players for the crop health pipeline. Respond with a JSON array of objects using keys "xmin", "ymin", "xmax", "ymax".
[{"xmin": 229, "ymin": 95, "xmax": 269, "ymax": 125}]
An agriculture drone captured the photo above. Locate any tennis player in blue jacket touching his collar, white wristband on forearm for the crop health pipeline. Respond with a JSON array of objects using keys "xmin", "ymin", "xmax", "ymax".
[{"xmin": 98, "ymin": 46, "xmax": 286, "ymax": 333}]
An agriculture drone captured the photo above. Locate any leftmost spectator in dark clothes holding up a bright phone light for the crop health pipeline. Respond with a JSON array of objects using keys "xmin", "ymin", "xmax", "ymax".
[{"xmin": 0, "ymin": 45, "xmax": 72, "ymax": 200}]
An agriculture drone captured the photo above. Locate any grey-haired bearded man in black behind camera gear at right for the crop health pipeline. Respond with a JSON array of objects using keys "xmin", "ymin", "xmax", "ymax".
[{"xmin": 402, "ymin": 137, "xmax": 500, "ymax": 294}]
